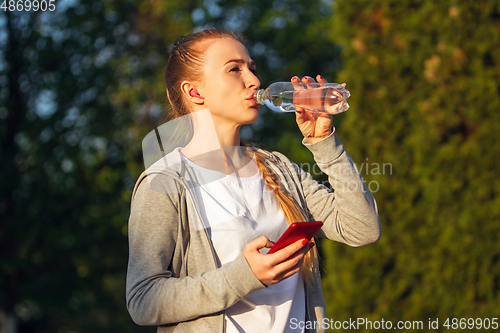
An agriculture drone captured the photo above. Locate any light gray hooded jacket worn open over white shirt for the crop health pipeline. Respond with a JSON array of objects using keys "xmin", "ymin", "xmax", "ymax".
[{"xmin": 126, "ymin": 133, "xmax": 381, "ymax": 333}]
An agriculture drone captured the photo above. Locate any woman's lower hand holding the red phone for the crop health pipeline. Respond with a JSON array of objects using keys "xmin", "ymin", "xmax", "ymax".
[{"xmin": 243, "ymin": 236, "xmax": 314, "ymax": 286}]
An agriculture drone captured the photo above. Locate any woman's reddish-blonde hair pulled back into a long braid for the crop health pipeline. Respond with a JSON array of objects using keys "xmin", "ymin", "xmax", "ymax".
[{"xmin": 165, "ymin": 29, "xmax": 318, "ymax": 284}]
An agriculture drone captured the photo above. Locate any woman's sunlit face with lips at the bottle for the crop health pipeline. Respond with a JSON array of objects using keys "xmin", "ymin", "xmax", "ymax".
[{"xmin": 198, "ymin": 38, "xmax": 260, "ymax": 127}]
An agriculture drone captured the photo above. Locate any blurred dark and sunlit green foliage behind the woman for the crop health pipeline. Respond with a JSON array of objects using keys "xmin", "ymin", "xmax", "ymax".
[{"xmin": 0, "ymin": 0, "xmax": 500, "ymax": 333}]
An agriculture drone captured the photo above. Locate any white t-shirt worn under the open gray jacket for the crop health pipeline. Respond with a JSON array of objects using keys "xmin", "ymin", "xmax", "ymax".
[{"xmin": 182, "ymin": 152, "xmax": 305, "ymax": 333}]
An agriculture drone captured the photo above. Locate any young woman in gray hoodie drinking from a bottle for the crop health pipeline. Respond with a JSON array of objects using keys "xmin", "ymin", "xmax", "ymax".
[{"xmin": 127, "ymin": 29, "xmax": 380, "ymax": 333}]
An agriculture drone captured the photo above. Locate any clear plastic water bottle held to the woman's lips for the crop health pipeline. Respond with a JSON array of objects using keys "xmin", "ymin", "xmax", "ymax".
[{"xmin": 253, "ymin": 82, "xmax": 351, "ymax": 114}]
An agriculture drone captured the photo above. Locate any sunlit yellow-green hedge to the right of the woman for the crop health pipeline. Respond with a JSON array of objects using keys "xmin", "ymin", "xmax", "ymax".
[{"xmin": 324, "ymin": 0, "xmax": 500, "ymax": 330}]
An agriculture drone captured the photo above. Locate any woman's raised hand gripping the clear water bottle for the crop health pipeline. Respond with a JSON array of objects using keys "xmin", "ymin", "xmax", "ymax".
[{"xmin": 292, "ymin": 75, "xmax": 345, "ymax": 143}]
